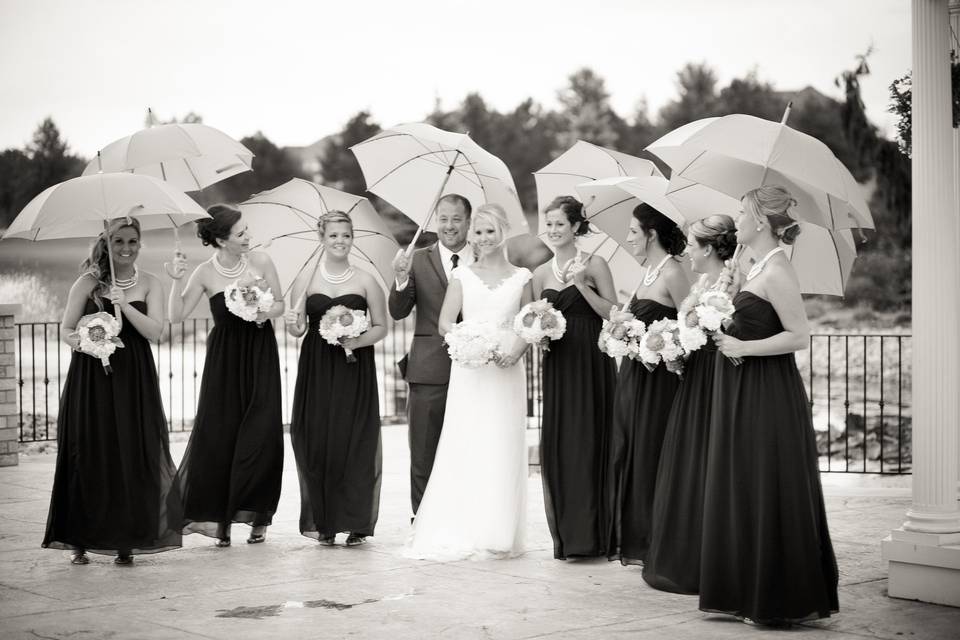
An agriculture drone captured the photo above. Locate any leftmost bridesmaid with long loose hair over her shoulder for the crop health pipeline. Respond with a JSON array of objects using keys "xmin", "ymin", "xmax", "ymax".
[{"xmin": 43, "ymin": 218, "xmax": 181, "ymax": 564}]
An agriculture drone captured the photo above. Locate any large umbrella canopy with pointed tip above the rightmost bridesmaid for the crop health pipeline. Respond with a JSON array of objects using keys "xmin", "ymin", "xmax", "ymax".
[{"xmin": 647, "ymin": 114, "xmax": 874, "ymax": 229}]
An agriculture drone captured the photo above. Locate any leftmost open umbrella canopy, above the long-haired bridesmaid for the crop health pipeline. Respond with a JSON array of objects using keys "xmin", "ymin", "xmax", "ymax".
[{"xmin": 4, "ymin": 173, "xmax": 209, "ymax": 240}]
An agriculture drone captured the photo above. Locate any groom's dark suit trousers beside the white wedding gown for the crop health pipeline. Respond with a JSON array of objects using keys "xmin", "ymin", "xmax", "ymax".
[{"xmin": 407, "ymin": 382, "xmax": 447, "ymax": 514}]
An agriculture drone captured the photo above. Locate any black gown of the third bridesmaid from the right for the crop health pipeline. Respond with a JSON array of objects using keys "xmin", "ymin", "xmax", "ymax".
[{"xmin": 606, "ymin": 299, "xmax": 680, "ymax": 564}]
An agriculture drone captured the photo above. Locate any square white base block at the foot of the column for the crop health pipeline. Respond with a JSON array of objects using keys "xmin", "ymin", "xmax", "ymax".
[{"xmin": 882, "ymin": 529, "xmax": 960, "ymax": 607}]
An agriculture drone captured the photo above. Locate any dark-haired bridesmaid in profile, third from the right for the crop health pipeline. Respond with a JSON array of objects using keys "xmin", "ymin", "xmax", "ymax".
[{"xmin": 605, "ymin": 203, "xmax": 690, "ymax": 565}]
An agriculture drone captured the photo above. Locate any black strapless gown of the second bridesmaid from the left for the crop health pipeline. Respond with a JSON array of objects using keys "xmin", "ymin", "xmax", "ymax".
[{"xmin": 177, "ymin": 292, "xmax": 283, "ymax": 538}]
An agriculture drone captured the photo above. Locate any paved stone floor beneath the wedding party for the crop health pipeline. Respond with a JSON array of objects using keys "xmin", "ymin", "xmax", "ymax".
[{"xmin": 0, "ymin": 426, "xmax": 960, "ymax": 640}]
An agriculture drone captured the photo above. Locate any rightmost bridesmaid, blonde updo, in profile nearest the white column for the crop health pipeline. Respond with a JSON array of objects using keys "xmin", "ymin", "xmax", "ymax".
[{"xmin": 700, "ymin": 186, "xmax": 838, "ymax": 626}]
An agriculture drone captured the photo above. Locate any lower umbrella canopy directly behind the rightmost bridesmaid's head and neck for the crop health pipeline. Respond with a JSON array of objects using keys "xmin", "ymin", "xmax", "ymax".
[{"xmin": 740, "ymin": 222, "xmax": 857, "ymax": 296}]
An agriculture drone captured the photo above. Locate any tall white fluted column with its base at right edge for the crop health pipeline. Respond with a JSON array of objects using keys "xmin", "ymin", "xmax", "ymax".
[{"xmin": 883, "ymin": 0, "xmax": 960, "ymax": 606}]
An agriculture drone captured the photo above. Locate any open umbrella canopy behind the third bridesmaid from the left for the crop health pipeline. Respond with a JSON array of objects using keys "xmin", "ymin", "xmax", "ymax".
[{"xmin": 240, "ymin": 178, "xmax": 399, "ymax": 298}]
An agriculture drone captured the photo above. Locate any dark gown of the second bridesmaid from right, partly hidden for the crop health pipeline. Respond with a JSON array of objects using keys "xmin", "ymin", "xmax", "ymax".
[{"xmin": 643, "ymin": 338, "xmax": 724, "ymax": 594}]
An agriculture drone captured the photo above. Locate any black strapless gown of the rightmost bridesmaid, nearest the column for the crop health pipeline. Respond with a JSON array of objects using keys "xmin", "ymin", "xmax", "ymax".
[{"xmin": 700, "ymin": 291, "xmax": 838, "ymax": 622}]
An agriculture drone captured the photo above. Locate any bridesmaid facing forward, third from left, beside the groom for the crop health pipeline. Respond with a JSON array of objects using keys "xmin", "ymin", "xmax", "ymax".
[{"xmin": 286, "ymin": 211, "xmax": 387, "ymax": 546}]
